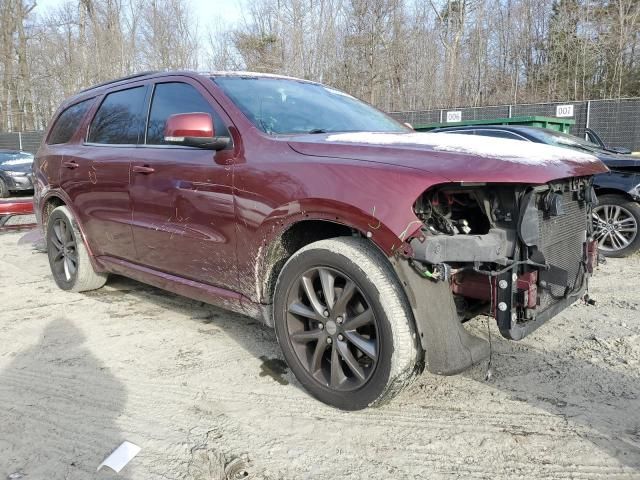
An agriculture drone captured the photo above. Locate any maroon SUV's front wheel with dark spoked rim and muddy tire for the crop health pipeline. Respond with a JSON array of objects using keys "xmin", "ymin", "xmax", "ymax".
[{"xmin": 274, "ymin": 237, "xmax": 422, "ymax": 410}]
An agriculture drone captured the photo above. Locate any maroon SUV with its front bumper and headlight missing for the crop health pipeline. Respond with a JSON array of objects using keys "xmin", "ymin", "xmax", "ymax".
[{"xmin": 35, "ymin": 72, "xmax": 606, "ymax": 409}]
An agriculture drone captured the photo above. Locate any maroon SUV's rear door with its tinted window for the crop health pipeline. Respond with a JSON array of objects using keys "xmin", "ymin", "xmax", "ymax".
[{"xmin": 68, "ymin": 84, "xmax": 148, "ymax": 261}]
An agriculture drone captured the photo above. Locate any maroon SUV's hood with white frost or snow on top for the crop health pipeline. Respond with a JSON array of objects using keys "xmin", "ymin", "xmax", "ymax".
[{"xmin": 288, "ymin": 132, "xmax": 607, "ymax": 184}]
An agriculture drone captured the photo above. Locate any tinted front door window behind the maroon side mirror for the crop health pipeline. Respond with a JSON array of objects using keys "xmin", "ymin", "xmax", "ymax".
[{"xmin": 147, "ymin": 82, "xmax": 229, "ymax": 145}]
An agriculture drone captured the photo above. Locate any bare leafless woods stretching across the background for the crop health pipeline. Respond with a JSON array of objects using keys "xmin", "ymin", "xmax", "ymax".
[{"xmin": 0, "ymin": 0, "xmax": 640, "ymax": 131}]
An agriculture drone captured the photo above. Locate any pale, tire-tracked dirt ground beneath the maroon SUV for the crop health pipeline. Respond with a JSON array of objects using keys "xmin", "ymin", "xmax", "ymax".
[{"xmin": 0, "ymin": 233, "xmax": 640, "ymax": 480}]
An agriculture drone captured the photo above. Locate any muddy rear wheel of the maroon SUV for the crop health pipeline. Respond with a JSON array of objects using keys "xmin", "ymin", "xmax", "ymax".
[{"xmin": 46, "ymin": 206, "xmax": 107, "ymax": 292}]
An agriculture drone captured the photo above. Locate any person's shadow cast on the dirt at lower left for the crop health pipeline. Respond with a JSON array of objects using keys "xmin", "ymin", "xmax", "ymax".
[{"xmin": 0, "ymin": 318, "xmax": 129, "ymax": 480}]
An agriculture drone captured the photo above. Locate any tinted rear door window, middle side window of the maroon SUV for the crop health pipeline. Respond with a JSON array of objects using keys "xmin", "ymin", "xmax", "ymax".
[{"xmin": 87, "ymin": 87, "xmax": 146, "ymax": 145}]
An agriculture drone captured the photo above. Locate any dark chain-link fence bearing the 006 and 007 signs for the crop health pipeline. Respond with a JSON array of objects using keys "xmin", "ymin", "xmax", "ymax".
[{"xmin": 391, "ymin": 98, "xmax": 640, "ymax": 151}]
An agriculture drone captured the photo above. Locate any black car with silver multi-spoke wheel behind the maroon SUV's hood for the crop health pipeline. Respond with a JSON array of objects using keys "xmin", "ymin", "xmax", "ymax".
[{"xmin": 432, "ymin": 125, "xmax": 640, "ymax": 257}]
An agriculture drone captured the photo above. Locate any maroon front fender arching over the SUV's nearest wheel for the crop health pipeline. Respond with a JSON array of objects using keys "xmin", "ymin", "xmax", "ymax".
[{"xmin": 234, "ymin": 157, "xmax": 450, "ymax": 303}]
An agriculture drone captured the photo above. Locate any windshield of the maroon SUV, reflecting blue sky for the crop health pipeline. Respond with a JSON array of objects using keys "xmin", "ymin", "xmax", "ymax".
[{"xmin": 213, "ymin": 76, "xmax": 408, "ymax": 134}]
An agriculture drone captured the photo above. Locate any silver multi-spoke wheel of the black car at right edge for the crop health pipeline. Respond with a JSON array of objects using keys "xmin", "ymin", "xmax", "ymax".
[{"xmin": 593, "ymin": 195, "xmax": 640, "ymax": 257}]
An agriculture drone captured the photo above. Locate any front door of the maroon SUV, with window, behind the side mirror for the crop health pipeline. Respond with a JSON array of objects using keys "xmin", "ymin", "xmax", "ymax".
[{"xmin": 131, "ymin": 77, "xmax": 237, "ymax": 290}]
